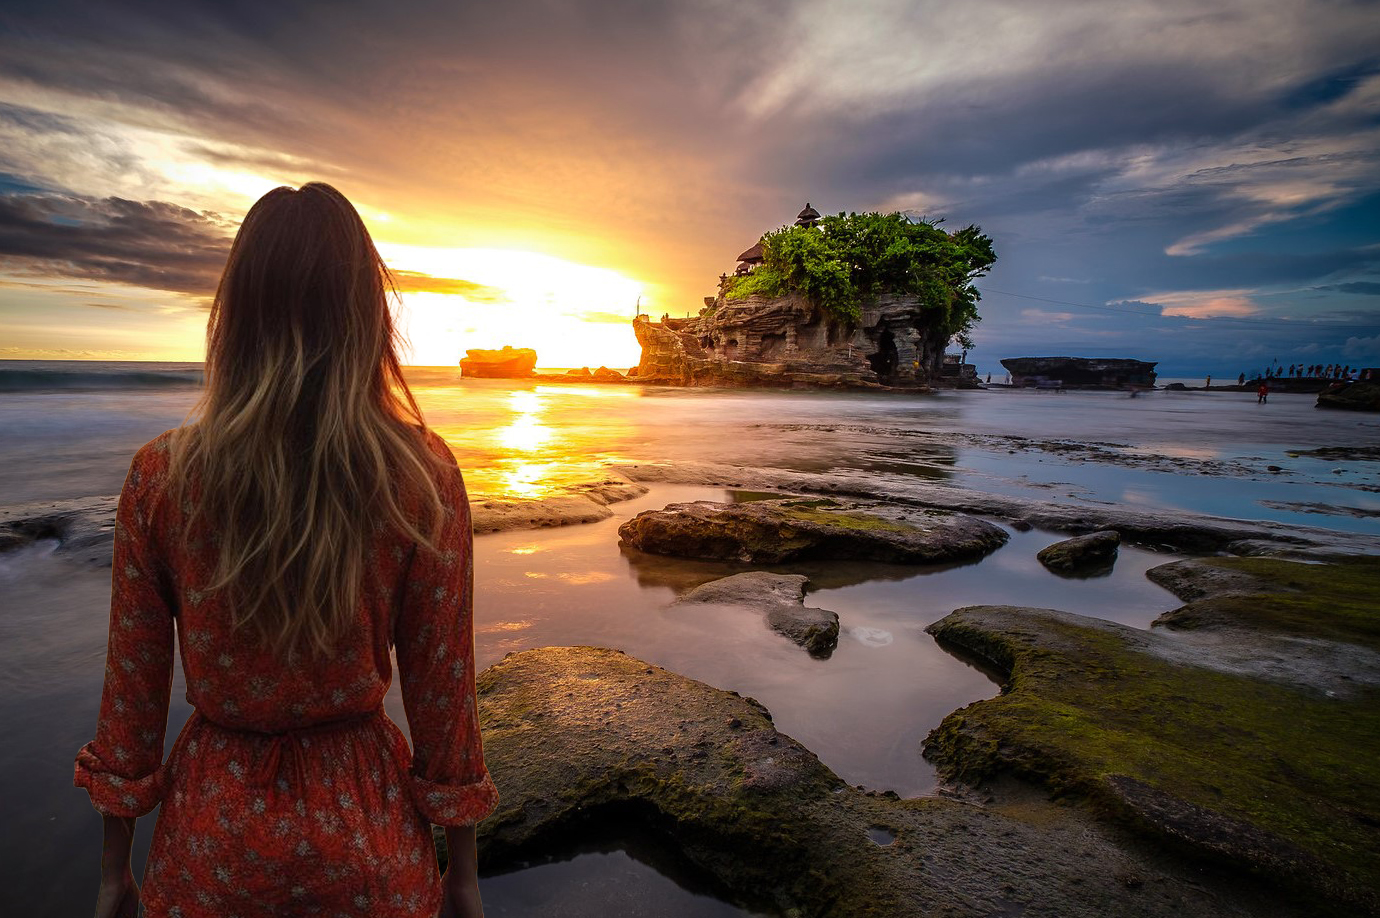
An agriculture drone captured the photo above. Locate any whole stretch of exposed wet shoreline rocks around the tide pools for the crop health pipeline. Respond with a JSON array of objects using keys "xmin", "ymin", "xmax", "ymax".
[{"xmin": 13, "ymin": 438, "xmax": 1380, "ymax": 918}]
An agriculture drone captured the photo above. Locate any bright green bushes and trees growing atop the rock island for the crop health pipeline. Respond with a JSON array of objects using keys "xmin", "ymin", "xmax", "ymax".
[{"xmin": 725, "ymin": 213, "xmax": 996, "ymax": 339}]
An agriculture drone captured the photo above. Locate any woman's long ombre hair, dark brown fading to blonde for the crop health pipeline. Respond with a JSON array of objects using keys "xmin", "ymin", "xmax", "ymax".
[{"xmin": 170, "ymin": 182, "xmax": 443, "ymax": 658}]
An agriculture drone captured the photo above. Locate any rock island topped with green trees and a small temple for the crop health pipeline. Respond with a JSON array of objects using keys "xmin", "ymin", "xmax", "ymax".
[{"xmin": 632, "ymin": 204, "xmax": 996, "ymax": 388}]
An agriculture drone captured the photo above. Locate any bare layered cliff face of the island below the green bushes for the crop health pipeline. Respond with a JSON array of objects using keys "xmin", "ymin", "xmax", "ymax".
[{"xmin": 632, "ymin": 295, "xmax": 948, "ymax": 388}]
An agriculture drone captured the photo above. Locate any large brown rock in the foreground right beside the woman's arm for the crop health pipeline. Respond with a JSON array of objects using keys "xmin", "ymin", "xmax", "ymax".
[{"xmin": 466, "ymin": 647, "xmax": 1299, "ymax": 918}]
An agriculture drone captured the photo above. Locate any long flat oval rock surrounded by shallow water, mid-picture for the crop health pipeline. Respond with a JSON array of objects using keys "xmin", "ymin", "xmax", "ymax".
[{"xmin": 618, "ymin": 498, "xmax": 1007, "ymax": 563}]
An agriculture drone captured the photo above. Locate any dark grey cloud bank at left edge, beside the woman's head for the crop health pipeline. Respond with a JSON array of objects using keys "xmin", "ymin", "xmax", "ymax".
[{"xmin": 0, "ymin": 195, "xmax": 230, "ymax": 295}]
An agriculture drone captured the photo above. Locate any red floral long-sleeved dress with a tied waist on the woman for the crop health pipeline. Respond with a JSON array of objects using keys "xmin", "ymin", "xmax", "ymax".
[{"xmin": 76, "ymin": 433, "xmax": 498, "ymax": 918}]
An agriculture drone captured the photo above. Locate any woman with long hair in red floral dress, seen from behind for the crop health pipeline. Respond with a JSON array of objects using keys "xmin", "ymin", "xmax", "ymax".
[{"xmin": 75, "ymin": 182, "xmax": 498, "ymax": 918}]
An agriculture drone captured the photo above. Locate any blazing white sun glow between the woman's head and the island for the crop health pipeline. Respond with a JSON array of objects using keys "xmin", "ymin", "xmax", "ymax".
[{"xmin": 380, "ymin": 243, "xmax": 647, "ymax": 370}]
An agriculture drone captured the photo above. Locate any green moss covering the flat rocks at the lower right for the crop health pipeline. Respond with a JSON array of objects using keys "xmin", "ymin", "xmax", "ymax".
[{"xmin": 926, "ymin": 559, "xmax": 1380, "ymax": 903}]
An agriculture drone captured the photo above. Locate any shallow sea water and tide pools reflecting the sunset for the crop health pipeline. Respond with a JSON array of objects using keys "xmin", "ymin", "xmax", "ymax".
[{"xmin": 0, "ymin": 362, "xmax": 1380, "ymax": 915}]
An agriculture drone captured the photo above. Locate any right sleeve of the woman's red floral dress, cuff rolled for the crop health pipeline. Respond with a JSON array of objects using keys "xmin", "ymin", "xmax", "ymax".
[{"xmin": 395, "ymin": 450, "xmax": 498, "ymax": 826}]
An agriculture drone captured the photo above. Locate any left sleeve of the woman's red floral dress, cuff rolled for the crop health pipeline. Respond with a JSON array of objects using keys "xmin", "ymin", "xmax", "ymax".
[{"xmin": 75, "ymin": 450, "xmax": 174, "ymax": 816}]
